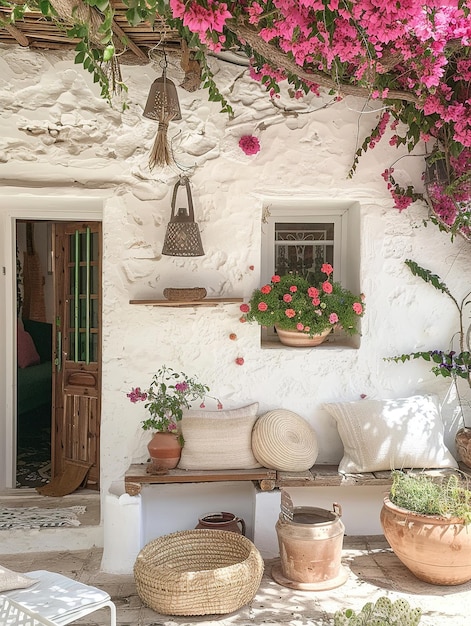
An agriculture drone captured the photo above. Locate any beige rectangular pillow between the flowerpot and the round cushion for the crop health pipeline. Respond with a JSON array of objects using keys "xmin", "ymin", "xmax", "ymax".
[{"xmin": 178, "ymin": 402, "xmax": 260, "ymax": 470}]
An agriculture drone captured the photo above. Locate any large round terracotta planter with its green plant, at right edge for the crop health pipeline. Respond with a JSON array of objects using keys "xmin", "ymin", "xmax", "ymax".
[{"xmin": 380, "ymin": 471, "xmax": 471, "ymax": 585}]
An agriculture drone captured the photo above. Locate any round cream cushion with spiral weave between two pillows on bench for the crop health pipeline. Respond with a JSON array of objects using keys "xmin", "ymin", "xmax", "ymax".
[{"xmin": 252, "ymin": 409, "xmax": 319, "ymax": 472}]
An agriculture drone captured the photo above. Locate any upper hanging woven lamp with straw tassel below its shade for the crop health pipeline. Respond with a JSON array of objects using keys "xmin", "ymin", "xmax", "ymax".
[{"xmin": 144, "ymin": 52, "xmax": 182, "ymax": 170}]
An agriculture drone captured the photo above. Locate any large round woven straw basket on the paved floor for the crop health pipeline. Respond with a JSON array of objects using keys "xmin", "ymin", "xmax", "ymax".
[{"xmin": 134, "ymin": 529, "xmax": 263, "ymax": 615}]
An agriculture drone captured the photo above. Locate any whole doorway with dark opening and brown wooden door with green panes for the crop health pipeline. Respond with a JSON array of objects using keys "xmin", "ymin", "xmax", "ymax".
[{"xmin": 16, "ymin": 219, "xmax": 102, "ymax": 488}]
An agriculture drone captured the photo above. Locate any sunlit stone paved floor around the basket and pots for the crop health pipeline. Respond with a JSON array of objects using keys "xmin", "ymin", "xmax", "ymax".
[{"xmin": 0, "ymin": 537, "xmax": 471, "ymax": 626}]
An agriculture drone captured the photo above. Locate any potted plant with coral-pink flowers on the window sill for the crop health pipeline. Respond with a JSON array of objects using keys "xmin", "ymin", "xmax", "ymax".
[{"xmin": 240, "ymin": 263, "xmax": 365, "ymax": 346}]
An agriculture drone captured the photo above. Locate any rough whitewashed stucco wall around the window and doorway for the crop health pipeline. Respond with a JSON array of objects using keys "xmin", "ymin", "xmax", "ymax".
[{"xmin": 0, "ymin": 47, "xmax": 471, "ymax": 564}]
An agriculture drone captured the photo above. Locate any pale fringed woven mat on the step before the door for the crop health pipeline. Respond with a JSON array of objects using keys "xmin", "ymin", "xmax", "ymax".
[{"xmin": 0, "ymin": 506, "xmax": 87, "ymax": 530}]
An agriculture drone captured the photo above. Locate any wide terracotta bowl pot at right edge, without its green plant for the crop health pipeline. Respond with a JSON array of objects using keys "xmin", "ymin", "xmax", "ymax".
[{"xmin": 381, "ymin": 497, "xmax": 471, "ymax": 585}]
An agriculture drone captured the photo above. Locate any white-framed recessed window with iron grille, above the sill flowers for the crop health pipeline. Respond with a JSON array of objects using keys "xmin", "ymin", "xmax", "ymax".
[{"xmin": 261, "ymin": 198, "xmax": 360, "ymax": 345}]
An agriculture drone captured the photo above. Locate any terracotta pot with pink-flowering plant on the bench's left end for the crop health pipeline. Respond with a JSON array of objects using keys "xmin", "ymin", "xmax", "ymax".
[{"xmin": 126, "ymin": 365, "xmax": 222, "ymax": 471}]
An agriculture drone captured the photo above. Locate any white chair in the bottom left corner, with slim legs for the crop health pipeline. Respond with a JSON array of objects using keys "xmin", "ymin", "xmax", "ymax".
[{"xmin": 0, "ymin": 570, "xmax": 116, "ymax": 626}]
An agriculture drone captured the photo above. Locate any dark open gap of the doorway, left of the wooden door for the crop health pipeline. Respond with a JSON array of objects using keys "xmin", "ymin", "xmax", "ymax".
[{"xmin": 16, "ymin": 220, "xmax": 54, "ymax": 488}]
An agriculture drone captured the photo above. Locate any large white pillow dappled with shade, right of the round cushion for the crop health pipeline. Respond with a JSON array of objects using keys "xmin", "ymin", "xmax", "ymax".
[{"xmin": 324, "ymin": 395, "xmax": 458, "ymax": 474}]
